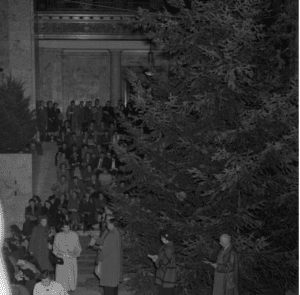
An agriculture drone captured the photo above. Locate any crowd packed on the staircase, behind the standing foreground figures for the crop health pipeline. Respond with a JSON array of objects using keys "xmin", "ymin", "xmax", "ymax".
[{"xmin": 32, "ymin": 99, "xmax": 138, "ymax": 234}]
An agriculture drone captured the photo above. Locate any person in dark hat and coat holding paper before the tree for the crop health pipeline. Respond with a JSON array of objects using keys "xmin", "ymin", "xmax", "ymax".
[{"xmin": 148, "ymin": 229, "xmax": 176, "ymax": 295}]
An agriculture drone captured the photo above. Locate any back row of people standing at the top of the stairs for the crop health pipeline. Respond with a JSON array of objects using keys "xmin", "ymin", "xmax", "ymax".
[{"xmin": 36, "ymin": 99, "xmax": 133, "ymax": 143}]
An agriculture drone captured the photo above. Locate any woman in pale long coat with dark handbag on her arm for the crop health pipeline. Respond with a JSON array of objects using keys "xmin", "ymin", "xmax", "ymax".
[{"xmin": 53, "ymin": 222, "xmax": 82, "ymax": 291}]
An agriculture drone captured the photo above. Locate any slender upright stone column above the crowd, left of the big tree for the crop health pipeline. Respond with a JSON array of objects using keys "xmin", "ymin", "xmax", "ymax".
[{"xmin": 109, "ymin": 50, "xmax": 122, "ymax": 107}]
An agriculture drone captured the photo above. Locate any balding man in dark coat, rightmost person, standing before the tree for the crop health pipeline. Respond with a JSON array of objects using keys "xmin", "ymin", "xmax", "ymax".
[{"xmin": 203, "ymin": 234, "xmax": 239, "ymax": 295}]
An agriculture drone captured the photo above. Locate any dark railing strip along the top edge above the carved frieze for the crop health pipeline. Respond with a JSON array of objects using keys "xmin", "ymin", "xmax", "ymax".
[{"xmin": 35, "ymin": 0, "xmax": 162, "ymax": 14}]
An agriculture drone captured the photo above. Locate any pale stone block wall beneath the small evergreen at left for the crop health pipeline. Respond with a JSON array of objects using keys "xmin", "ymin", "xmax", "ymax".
[{"xmin": 0, "ymin": 154, "xmax": 32, "ymax": 233}]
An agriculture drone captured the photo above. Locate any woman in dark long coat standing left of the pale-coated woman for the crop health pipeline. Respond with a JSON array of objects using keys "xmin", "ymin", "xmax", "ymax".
[{"xmin": 28, "ymin": 215, "xmax": 53, "ymax": 271}]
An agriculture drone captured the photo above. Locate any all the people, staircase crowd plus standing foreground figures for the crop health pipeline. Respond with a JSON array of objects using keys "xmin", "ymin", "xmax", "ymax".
[{"xmin": 3, "ymin": 99, "xmax": 238, "ymax": 295}]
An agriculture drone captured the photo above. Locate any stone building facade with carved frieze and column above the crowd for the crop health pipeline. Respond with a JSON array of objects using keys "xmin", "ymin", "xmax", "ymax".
[{"xmin": 0, "ymin": 0, "xmax": 168, "ymax": 114}]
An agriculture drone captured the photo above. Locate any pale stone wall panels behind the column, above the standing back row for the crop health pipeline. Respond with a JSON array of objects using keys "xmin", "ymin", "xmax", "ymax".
[{"xmin": 36, "ymin": 48, "xmax": 168, "ymax": 115}]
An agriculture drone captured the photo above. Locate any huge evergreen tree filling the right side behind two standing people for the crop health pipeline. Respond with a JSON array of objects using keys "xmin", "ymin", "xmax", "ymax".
[{"xmin": 113, "ymin": 0, "xmax": 298, "ymax": 295}]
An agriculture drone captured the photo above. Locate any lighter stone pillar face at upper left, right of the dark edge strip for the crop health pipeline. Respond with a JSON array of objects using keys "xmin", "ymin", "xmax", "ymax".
[{"xmin": 8, "ymin": 0, "xmax": 35, "ymax": 109}]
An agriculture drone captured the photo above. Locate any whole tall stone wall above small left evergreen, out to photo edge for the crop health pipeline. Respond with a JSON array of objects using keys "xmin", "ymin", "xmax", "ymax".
[{"xmin": 0, "ymin": 0, "xmax": 35, "ymax": 108}]
